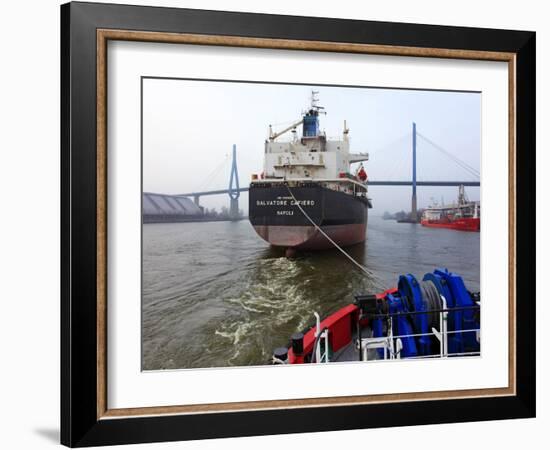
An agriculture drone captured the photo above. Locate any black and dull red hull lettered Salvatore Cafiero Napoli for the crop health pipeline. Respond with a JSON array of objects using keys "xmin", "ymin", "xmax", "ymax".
[{"xmin": 249, "ymin": 183, "xmax": 368, "ymax": 250}]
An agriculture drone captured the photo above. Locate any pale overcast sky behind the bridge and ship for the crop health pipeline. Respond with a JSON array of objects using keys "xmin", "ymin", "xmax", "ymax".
[{"xmin": 143, "ymin": 79, "xmax": 481, "ymax": 214}]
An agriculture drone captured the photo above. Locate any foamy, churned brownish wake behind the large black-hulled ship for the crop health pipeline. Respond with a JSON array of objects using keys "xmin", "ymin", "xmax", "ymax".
[{"xmin": 215, "ymin": 255, "xmax": 384, "ymax": 365}]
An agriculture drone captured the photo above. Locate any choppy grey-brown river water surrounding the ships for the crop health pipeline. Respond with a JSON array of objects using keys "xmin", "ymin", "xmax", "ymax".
[{"xmin": 142, "ymin": 216, "xmax": 480, "ymax": 370}]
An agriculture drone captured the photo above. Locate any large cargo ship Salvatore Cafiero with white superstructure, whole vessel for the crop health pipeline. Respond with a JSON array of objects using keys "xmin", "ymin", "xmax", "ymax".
[{"xmin": 249, "ymin": 91, "xmax": 372, "ymax": 254}]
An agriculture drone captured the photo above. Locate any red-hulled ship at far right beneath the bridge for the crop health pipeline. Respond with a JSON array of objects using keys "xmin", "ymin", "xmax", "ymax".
[{"xmin": 420, "ymin": 185, "xmax": 481, "ymax": 231}]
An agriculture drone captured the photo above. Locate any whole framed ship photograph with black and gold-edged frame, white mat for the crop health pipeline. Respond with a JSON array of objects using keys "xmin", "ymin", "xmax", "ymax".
[{"xmin": 61, "ymin": 3, "xmax": 535, "ymax": 446}]
